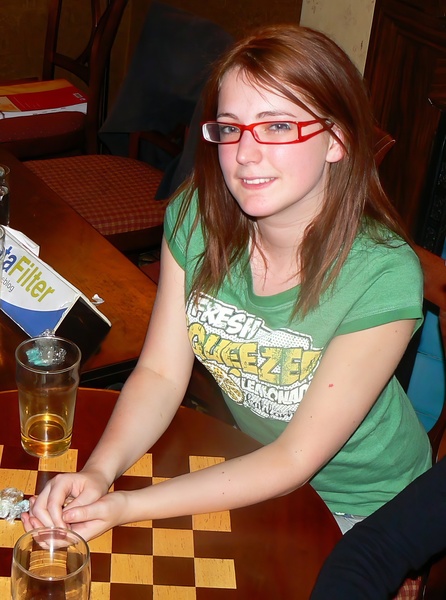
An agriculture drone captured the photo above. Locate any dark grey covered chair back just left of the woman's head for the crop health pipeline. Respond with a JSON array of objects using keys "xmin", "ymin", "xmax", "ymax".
[{"xmin": 99, "ymin": 0, "xmax": 233, "ymax": 170}]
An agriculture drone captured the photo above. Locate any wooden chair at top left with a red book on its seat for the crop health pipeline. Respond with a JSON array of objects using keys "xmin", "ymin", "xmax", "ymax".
[{"xmin": 0, "ymin": 0, "xmax": 128, "ymax": 159}]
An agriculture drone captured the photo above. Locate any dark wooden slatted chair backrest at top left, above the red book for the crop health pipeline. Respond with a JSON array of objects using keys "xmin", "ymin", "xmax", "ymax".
[{"xmin": 42, "ymin": 0, "xmax": 128, "ymax": 154}]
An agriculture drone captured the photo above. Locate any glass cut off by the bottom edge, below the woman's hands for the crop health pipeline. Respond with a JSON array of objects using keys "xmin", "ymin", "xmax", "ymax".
[{"xmin": 11, "ymin": 527, "xmax": 91, "ymax": 600}]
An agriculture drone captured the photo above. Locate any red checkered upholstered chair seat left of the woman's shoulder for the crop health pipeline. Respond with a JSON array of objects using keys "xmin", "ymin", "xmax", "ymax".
[{"xmin": 26, "ymin": 155, "xmax": 167, "ymax": 235}]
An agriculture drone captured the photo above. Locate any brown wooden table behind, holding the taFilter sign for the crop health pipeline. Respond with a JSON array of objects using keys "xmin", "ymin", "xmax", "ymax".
[{"xmin": 0, "ymin": 149, "xmax": 156, "ymax": 390}]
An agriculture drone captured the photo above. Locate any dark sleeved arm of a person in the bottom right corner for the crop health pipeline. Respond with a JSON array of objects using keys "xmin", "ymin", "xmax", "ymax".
[{"xmin": 311, "ymin": 458, "xmax": 446, "ymax": 600}]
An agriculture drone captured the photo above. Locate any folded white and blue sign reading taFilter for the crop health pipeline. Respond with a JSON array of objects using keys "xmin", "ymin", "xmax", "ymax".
[{"xmin": 0, "ymin": 227, "xmax": 111, "ymax": 358}]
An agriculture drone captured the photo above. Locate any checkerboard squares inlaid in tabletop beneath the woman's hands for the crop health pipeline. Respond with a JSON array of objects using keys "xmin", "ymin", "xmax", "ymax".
[{"xmin": 0, "ymin": 446, "xmax": 237, "ymax": 600}]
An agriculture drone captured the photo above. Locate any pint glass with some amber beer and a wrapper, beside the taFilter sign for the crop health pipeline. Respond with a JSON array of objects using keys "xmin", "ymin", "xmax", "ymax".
[{"xmin": 15, "ymin": 336, "xmax": 81, "ymax": 457}]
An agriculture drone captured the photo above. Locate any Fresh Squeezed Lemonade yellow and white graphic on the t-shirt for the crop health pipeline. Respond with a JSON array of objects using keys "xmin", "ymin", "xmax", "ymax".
[{"xmin": 187, "ymin": 295, "xmax": 321, "ymax": 421}]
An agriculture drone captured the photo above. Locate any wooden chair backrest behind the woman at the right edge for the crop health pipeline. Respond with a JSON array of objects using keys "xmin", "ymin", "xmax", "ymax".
[{"xmin": 414, "ymin": 241, "xmax": 446, "ymax": 462}]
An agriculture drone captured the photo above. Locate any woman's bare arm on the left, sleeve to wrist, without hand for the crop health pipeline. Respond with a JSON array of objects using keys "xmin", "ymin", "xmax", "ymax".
[{"xmin": 84, "ymin": 234, "xmax": 194, "ymax": 484}]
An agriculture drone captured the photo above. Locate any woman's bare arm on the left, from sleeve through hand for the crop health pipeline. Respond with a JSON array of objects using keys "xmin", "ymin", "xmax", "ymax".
[{"xmin": 24, "ymin": 237, "xmax": 194, "ymax": 528}]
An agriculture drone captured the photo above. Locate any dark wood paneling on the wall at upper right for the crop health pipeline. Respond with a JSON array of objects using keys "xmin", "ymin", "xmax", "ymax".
[{"xmin": 365, "ymin": 0, "xmax": 446, "ymax": 245}]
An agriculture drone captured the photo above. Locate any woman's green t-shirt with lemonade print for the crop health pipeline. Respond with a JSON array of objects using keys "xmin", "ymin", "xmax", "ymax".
[{"xmin": 165, "ymin": 191, "xmax": 431, "ymax": 516}]
